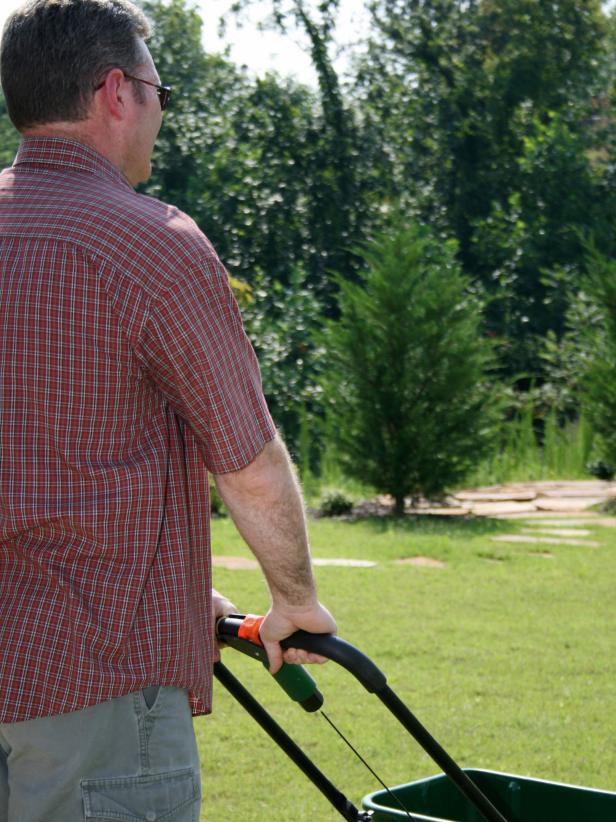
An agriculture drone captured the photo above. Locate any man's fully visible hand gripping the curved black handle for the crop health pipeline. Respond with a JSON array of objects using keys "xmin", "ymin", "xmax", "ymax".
[{"xmin": 259, "ymin": 601, "xmax": 336, "ymax": 674}]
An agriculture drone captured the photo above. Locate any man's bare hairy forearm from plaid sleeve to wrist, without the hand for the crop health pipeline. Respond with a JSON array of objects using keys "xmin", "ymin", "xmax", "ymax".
[{"xmin": 215, "ymin": 438, "xmax": 316, "ymax": 609}]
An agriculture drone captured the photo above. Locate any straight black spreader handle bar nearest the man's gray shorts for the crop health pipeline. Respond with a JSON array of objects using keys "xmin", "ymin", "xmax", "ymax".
[{"xmin": 214, "ymin": 662, "xmax": 372, "ymax": 822}]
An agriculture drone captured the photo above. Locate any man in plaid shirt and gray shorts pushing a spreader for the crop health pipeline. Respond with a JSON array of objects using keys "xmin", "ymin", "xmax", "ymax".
[{"xmin": 0, "ymin": 0, "xmax": 335, "ymax": 822}]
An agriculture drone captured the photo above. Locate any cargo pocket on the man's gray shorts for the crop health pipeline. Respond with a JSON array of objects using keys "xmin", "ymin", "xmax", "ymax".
[{"xmin": 81, "ymin": 768, "xmax": 201, "ymax": 822}]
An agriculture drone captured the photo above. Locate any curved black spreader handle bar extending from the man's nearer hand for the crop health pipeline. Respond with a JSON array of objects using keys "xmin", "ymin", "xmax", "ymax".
[{"xmin": 217, "ymin": 615, "xmax": 508, "ymax": 822}]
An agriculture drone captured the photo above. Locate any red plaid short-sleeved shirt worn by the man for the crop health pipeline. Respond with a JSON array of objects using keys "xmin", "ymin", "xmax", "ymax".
[{"xmin": 0, "ymin": 138, "xmax": 275, "ymax": 722}]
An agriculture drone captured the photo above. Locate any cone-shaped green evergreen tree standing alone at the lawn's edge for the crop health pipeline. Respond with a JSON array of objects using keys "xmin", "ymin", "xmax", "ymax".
[{"xmin": 326, "ymin": 225, "xmax": 495, "ymax": 512}]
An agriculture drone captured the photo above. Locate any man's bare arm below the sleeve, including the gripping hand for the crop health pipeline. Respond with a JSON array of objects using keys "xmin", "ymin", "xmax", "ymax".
[{"xmin": 215, "ymin": 437, "xmax": 336, "ymax": 673}]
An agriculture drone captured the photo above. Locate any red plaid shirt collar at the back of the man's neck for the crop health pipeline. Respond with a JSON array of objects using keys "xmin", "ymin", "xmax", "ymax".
[{"xmin": 13, "ymin": 137, "xmax": 133, "ymax": 190}]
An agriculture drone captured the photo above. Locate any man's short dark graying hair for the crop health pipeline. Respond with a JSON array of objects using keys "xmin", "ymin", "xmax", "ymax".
[{"xmin": 0, "ymin": 0, "xmax": 151, "ymax": 130}]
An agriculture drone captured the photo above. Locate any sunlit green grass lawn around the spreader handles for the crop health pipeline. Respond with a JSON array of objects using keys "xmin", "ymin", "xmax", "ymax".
[{"xmin": 195, "ymin": 519, "xmax": 616, "ymax": 822}]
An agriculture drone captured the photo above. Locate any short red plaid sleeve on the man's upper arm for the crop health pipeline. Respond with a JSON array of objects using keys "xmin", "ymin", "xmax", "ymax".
[{"xmin": 137, "ymin": 253, "xmax": 276, "ymax": 474}]
